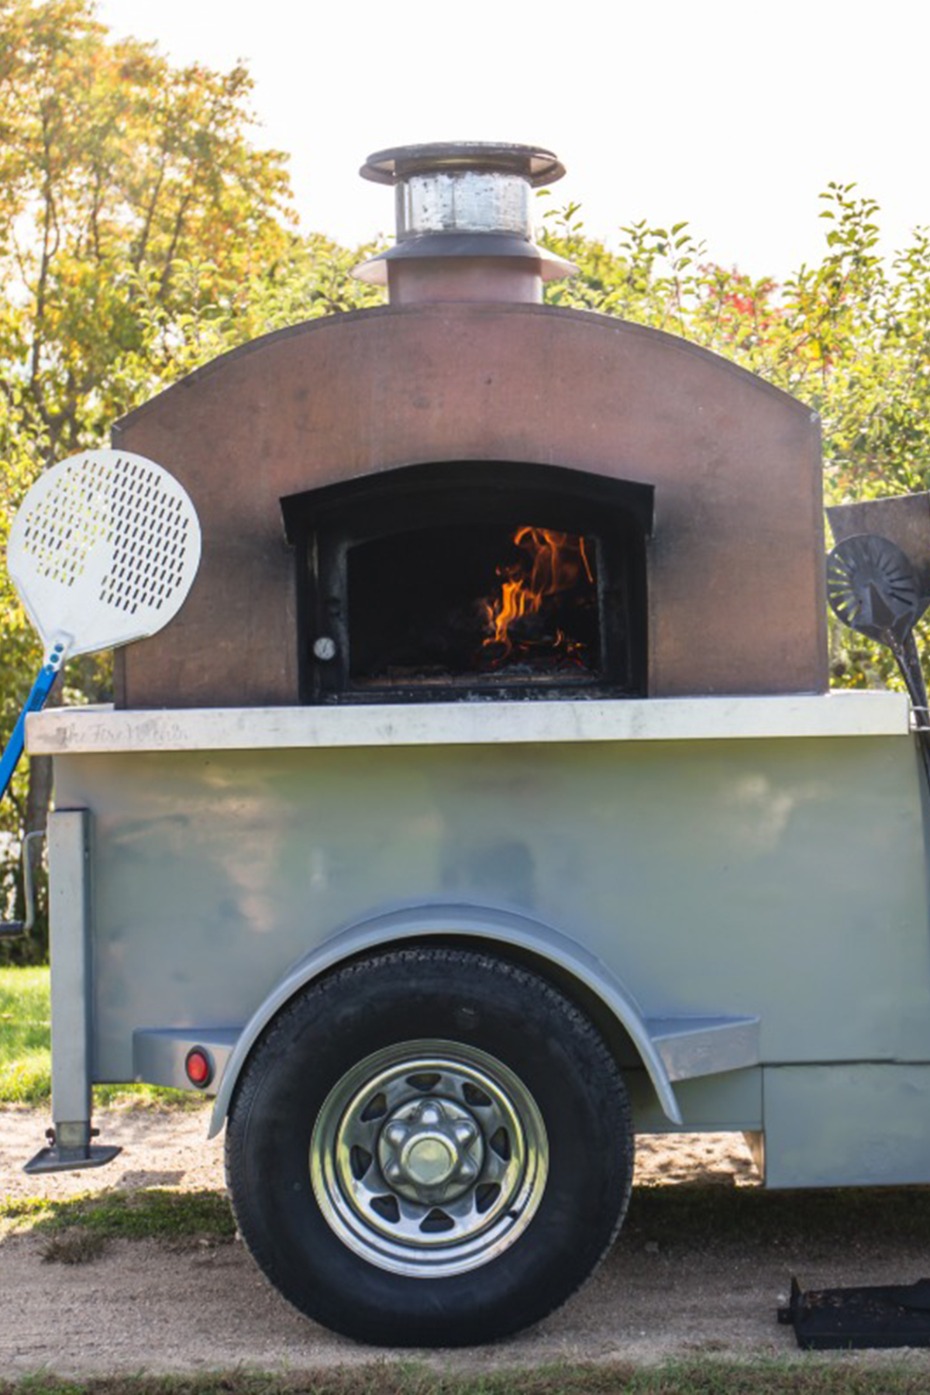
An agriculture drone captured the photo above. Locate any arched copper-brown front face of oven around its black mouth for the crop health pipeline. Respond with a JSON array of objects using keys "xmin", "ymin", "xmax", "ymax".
[{"xmin": 113, "ymin": 303, "xmax": 827, "ymax": 707}]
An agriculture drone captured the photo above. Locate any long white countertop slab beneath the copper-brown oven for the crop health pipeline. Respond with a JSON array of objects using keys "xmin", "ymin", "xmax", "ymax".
[{"xmin": 26, "ymin": 692, "xmax": 909, "ymax": 756}]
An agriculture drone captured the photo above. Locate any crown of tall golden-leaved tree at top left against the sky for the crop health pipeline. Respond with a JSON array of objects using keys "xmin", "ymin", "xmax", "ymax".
[{"xmin": 0, "ymin": 0, "xmax": 289, "ymax": 458}]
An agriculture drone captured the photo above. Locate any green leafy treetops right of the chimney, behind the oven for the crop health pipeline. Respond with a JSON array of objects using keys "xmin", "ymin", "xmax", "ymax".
[{"xmin": 544, "ymin": 184, "xmax": 930, "ymax": 502}]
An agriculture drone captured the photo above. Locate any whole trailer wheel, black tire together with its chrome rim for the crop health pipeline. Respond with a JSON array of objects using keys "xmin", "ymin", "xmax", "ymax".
[{"xmin": 226, "ymin": 947, "xmax": 633, "ymax": 1346}]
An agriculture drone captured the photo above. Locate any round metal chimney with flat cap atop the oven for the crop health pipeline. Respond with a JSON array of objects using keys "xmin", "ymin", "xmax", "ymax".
[{"xmin": 354, "ymin": 141, "xmax": 574, "ymax": 304}]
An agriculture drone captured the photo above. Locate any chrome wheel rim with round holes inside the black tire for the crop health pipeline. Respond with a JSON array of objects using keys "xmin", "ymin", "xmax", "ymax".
[{"xmin": 310, "ymin": 1041, "xmax": 549, "ymax": 1278}]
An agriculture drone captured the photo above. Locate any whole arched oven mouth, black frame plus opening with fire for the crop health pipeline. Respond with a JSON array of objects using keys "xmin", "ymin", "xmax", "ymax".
[{"xmin": 283, "ymin": 462, "xmax": 651, "ymax": 702}]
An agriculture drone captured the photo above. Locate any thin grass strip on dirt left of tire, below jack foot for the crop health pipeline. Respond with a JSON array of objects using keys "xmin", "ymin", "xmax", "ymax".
[{"xmin": 0, "ymin": 1187, "xmax": 236, "ymax": 1244}]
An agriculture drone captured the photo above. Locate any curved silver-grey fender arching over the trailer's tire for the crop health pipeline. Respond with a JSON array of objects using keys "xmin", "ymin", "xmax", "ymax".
[{"xmin": 209, "ymin": 905, "xmax": 683, "ymax": 1138}]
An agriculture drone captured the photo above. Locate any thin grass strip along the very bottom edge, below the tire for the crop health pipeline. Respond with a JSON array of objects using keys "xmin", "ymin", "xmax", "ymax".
[{"xmin": 0, "ymin": 1357, "xmax": 927, "ymax": 1395}]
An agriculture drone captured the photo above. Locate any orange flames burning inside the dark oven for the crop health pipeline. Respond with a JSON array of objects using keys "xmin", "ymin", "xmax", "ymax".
[{"xmin": 481, "ymin": 525, "xmax": 594, "ymax": 663}]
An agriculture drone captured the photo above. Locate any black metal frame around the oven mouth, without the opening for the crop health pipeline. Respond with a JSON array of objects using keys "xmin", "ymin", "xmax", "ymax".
[{"xmin": 280, "ymin": 460, "xmax": 655, "ymax": 704}]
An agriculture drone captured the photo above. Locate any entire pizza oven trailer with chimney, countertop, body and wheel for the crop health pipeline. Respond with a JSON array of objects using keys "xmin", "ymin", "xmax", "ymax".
[{"xmin": 10, "ymin": 145, "xmax": 930, "ymax": 1346}]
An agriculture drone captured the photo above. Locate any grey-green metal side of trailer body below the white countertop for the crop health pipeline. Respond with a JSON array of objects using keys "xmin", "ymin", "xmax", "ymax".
[{"xmin": 34, "ymin": 699, "xmax": 930, "ymax": 1186}]
